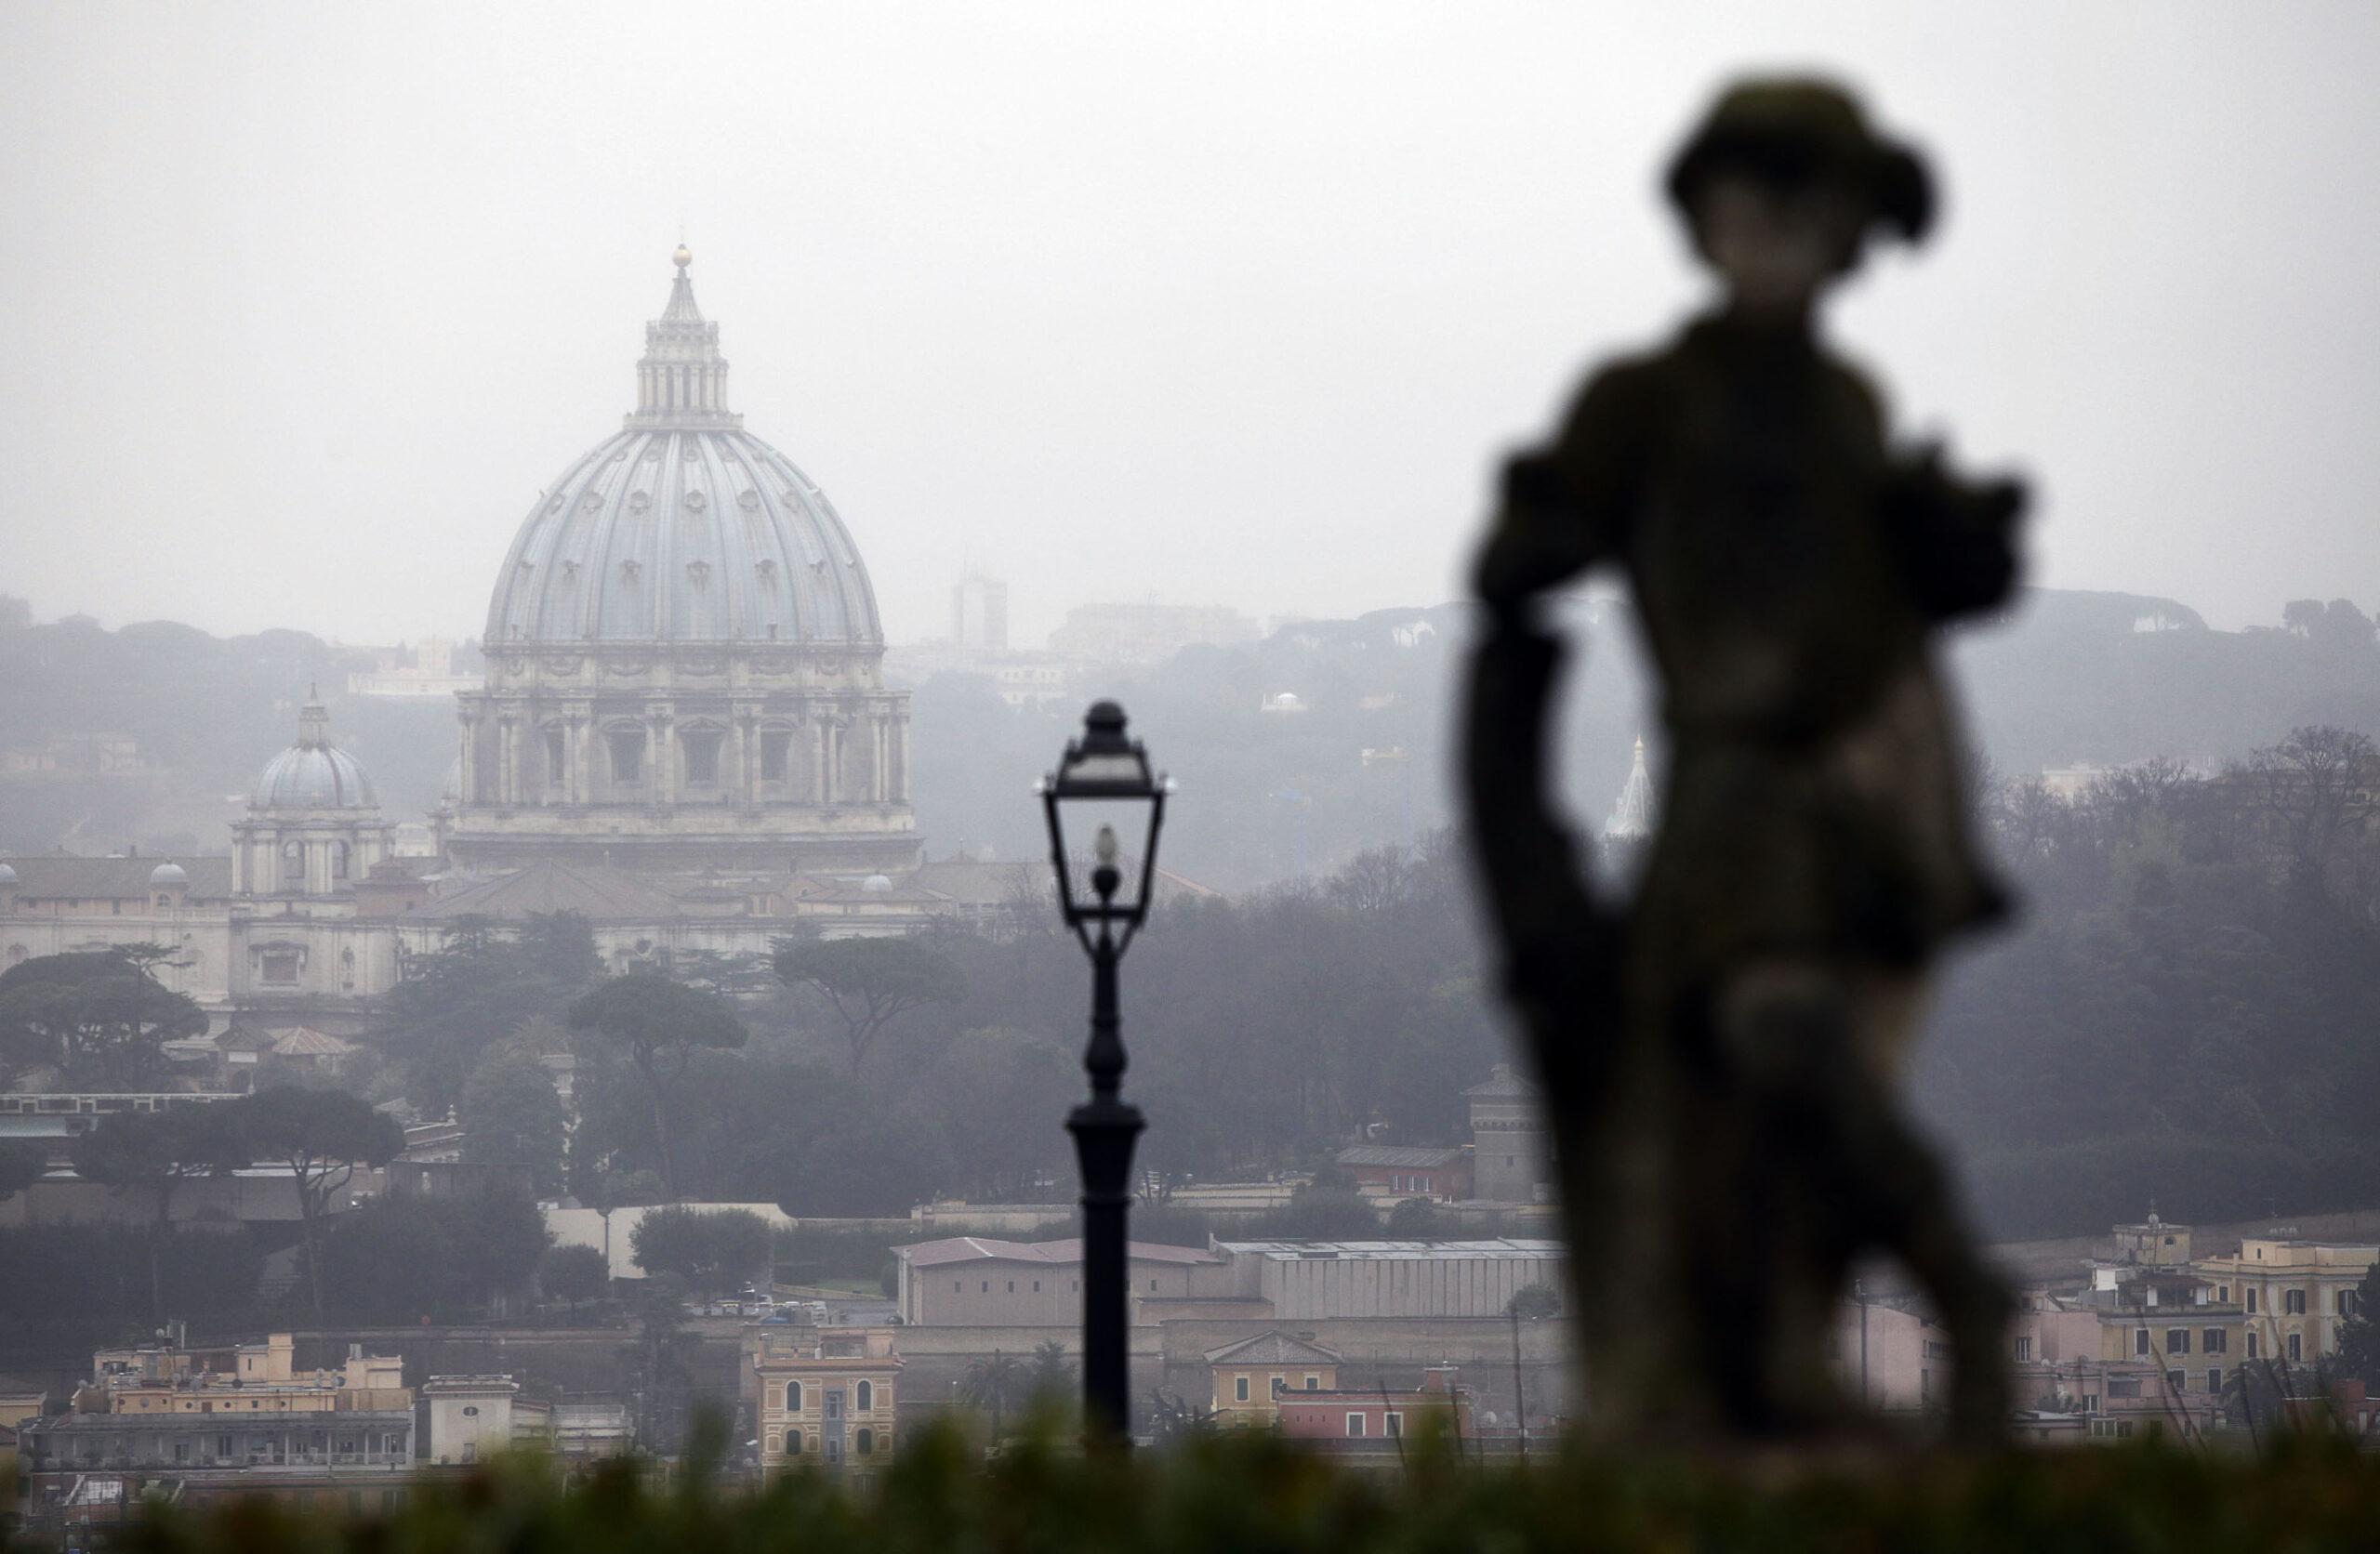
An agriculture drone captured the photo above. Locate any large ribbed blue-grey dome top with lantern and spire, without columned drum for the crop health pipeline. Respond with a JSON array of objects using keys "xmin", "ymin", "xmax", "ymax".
[{"xmin": 485, "ymin": 250, "xmax": 883, "ymax": 647}]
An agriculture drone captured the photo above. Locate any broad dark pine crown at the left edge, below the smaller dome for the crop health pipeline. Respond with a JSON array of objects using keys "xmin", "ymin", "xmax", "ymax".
[{"xmin": 0, "ymin": 945, "xmax": 207, "ymax": 1090}]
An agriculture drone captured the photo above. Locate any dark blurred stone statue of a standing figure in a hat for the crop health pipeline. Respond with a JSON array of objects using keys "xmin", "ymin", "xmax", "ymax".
[{"xmin": 1466, "ymin": 78, "xmax": 2023, "ymax": 1440}]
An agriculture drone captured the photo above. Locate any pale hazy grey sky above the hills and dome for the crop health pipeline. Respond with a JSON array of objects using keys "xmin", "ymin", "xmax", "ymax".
[{"xmin": 0, "ymin": 0, "xmax": 2380, "ymax": 642}]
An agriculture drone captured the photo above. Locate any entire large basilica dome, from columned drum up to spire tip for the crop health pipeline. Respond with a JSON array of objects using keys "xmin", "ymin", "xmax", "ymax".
[{"xmin": 445, "ymin": 247, "xmax": 919, "ymax": 874}]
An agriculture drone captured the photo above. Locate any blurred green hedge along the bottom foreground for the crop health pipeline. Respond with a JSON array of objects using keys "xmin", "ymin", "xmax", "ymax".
[{"xmin": 28, "ymin": 1430, "xmax": 2380, "ymax": 1554}]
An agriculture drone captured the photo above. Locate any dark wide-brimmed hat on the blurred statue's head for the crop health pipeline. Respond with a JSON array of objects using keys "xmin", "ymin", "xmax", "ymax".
[{"xmin": 1669, "ymin": 76, "xmax": 1935, "ymax": 243}]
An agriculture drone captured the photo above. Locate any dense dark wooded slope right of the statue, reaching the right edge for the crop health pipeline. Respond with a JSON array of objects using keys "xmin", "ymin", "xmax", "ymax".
[{"xmin": 1921, "ymin": 729, "xmax": 2380, "ymax": 1235}]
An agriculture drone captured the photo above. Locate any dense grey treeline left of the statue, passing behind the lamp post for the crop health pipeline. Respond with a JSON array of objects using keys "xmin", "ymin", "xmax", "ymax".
[{"xmin": 521, "ymin": 840, "xmax": 1500, "ymax": 1216}]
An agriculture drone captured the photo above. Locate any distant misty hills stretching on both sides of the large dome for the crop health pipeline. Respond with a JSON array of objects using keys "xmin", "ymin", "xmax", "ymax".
[{"xmin": 0, "ymin": 590, "xmax": 2380, "ymax": 890}]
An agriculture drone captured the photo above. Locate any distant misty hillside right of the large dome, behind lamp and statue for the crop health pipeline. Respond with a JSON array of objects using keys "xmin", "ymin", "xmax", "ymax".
[{"xmin": 917, "ymin": 590, "xmax": 2380, "ymax": 888}]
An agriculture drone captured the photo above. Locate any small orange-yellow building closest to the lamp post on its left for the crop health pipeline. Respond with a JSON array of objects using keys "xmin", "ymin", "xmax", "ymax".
[{"xmin": 745, "ymin": 1325, "xmax": 902, "ymax": 1482}]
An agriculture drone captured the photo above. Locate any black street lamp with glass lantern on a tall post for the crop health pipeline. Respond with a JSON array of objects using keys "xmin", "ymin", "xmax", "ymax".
[{"xmin": 1040, "ymin": 702, "xmax": 1169, "ymax": 1444}]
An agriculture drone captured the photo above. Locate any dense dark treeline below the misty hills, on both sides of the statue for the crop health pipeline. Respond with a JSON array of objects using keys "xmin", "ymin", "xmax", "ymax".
[{"xmin": 390, "ymin": 729, "xmax": 2380, "ymax": 1235}]
